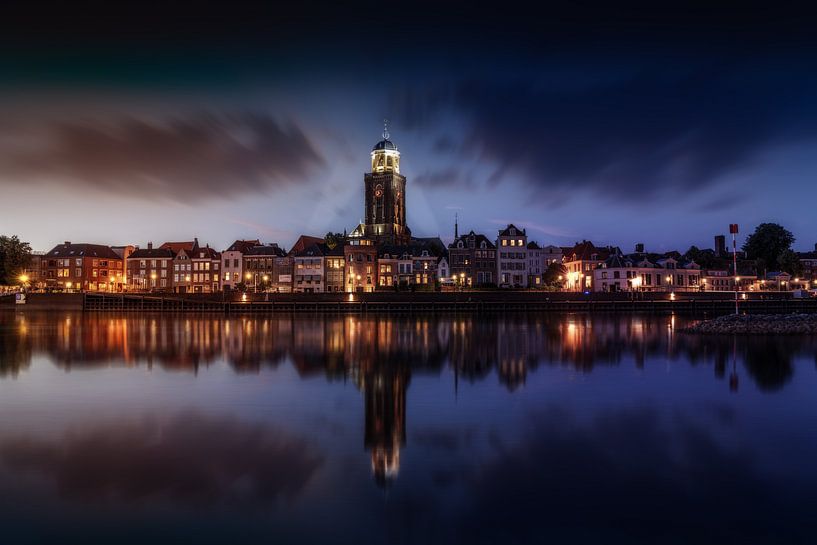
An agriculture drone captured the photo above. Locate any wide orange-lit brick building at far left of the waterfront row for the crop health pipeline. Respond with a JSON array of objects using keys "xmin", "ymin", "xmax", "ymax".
[{"xmin": 40, "ymin": 241, "xmax": 124, "ymax": 292}]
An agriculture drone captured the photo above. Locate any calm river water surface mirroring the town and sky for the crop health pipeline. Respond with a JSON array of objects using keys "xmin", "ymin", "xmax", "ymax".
[{"xmin": 0, "ymin": 312, "xmax": 817, "ymax": 544}]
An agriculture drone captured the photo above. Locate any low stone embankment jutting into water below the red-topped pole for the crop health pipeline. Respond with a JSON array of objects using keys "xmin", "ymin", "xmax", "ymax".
[{"xmin": 683, "ymin": 314, "xmax": 817, "ymax": 335}]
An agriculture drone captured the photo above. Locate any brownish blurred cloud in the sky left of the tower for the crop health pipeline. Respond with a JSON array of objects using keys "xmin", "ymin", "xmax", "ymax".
[{"xmin": 0, "ymin": 113, "xmax": 325, "ymax": 201}]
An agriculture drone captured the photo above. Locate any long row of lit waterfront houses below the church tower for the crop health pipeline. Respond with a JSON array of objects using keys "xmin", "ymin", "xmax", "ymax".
[{"xmin": 27, "ymin": 224, "xmax": 817, "ymax": 293}]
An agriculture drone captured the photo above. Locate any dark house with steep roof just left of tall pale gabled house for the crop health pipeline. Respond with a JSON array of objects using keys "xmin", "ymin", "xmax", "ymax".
[{"xmin": 448, "ymin": 231, "xmax": 497, "ymax": 287}]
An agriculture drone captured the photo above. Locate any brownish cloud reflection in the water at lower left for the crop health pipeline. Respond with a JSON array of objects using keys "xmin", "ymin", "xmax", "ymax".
[{"xmin": 0, "ymin": 413, "xmax": 323, "ymax": 507}]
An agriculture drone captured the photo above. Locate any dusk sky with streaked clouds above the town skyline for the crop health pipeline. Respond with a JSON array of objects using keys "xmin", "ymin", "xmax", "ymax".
[{"xmin": 0, "ymin": 2, "xmax": 817, "ymax": 251}]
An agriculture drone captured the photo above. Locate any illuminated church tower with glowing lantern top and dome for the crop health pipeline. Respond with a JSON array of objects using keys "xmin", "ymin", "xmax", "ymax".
[{"xmin": 351, "ymin": 121, "xmax": 411, "ymax": 244}]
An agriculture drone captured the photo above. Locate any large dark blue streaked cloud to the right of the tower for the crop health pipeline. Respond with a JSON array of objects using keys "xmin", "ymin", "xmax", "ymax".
[{"xmin": 393, "ymin": 52, "xmax": 817, "ymax": 201}]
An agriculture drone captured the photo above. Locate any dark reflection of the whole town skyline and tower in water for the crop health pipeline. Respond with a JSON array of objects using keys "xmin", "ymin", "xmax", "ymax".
[{"xmin": 0, "ymin": 313, "xmax": 817, "ymax": 485}]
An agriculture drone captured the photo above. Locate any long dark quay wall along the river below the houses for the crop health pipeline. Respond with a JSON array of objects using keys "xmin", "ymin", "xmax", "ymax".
[{"xmin": 0, "ymin": 291, "xmax": 817, "ymax": 314}]
